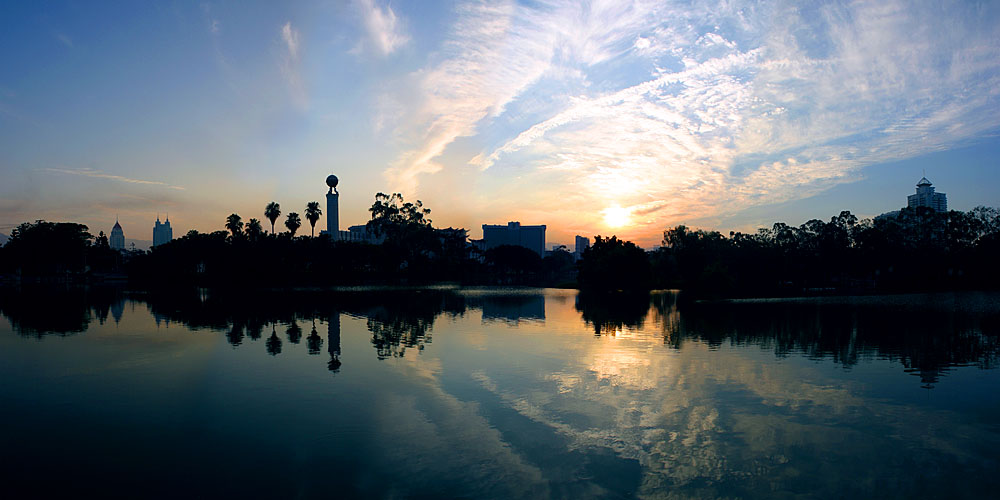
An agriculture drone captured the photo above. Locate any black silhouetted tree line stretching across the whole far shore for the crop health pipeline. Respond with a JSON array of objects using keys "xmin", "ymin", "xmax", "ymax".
[{"xmin": 0, "ymin": 193, "xmax": 1000, "ymax": 297}]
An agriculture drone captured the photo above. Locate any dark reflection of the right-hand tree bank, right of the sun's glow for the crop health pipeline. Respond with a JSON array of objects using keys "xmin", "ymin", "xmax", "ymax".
[{"xmin": 654, "ymin": 294, "xmax": 1000, "ymax": 388}]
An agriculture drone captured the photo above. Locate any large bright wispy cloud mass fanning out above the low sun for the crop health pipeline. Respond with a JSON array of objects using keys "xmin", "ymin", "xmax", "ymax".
[{"xmin": 386, "ymin": 1, "xmax": 1000, "ymax": 242}]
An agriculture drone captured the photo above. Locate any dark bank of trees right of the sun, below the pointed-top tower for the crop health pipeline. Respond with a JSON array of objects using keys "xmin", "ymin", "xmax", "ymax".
[{"xmin": 650, "ymin": 207, "xmax": 1000, "ymax": 296}]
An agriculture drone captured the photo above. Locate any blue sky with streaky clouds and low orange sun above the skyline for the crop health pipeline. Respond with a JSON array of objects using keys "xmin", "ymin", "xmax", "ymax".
[{"xmin": 0, "ymin": 0, "xmax": 1000, "ymax": 248}]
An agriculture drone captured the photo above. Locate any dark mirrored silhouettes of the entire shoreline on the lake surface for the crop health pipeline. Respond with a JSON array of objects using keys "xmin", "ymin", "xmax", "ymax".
[{"xmin": 0, "ymin": 288, "xmax": 1000, "ymax": 388}]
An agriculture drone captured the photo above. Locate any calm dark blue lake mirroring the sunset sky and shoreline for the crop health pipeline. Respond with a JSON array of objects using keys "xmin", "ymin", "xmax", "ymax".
[{"xmin": 0, "ymin": 289, "xmax": 1000, "ymax": 498}]
